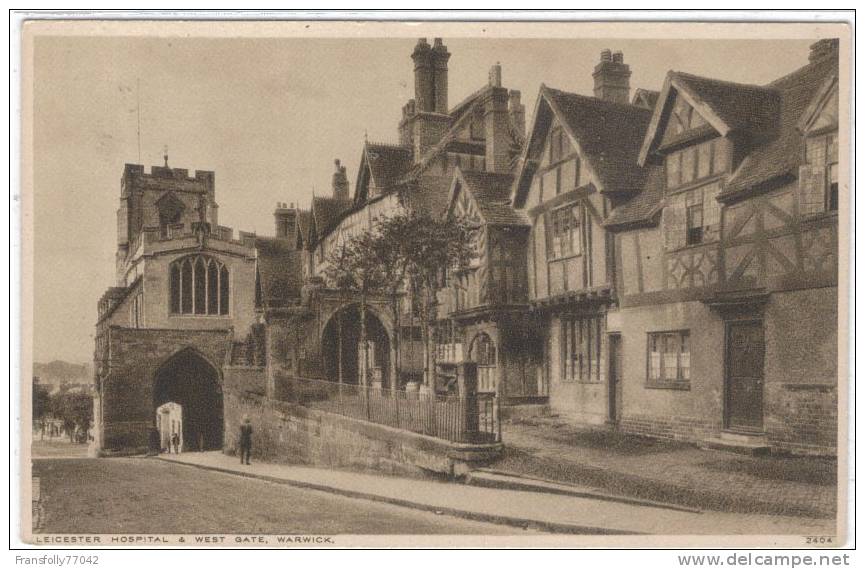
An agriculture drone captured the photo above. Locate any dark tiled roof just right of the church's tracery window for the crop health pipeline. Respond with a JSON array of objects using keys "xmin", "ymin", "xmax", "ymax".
[{"xmin": 255, "ymin": 237, "xmax": 303, "ymax": 307}]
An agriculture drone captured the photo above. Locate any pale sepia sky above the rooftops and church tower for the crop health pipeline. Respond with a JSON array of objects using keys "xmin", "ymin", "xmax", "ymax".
[{"xmin": 25, "ymin": 30, "xmax": 811, "ymax": 363}]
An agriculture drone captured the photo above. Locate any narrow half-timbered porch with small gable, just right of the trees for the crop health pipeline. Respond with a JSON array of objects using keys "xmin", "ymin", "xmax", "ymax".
[{"xmin": 439, "ymin": 168, "xmax": 544, "ymax": 403}]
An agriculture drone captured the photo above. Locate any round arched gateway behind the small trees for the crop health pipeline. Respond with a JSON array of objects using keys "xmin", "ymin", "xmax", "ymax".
[{"xmin": 321, "ymin": 304, "xmax": 390, "ymax": 387}]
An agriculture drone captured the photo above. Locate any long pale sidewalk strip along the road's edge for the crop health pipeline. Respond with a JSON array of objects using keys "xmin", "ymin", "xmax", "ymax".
[{"xmin": 159, "ymin": 452, "xmax": 835, "ymax": 535}]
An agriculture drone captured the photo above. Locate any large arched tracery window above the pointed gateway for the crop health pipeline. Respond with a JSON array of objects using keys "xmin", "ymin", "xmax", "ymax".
[{"xmin": 168, "ymin": 255, "xmax": 231, "ymax": 316}]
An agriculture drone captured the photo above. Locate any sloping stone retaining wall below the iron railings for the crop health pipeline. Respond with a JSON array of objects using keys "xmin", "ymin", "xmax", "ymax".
[{"xmin": 225, "ymin": 392, "xmax": 502, "ymax": 476}]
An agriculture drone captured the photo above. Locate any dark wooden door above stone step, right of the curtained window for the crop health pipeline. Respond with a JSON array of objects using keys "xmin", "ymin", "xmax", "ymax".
[{"xmin": 726, "ymin": 320, "xmax": 765, "ymax": 431}]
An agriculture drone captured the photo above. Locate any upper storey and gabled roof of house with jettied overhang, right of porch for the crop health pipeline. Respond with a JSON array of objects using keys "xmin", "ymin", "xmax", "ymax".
[{"xmin": 514, "ymin": 86, "xmax": 650, "ymax": 302}]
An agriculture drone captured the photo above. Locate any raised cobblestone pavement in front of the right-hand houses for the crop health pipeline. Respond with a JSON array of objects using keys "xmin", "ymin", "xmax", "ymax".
[{"xmin": 491, "ymin": 417, "xmax": 837, "ymax": 518}]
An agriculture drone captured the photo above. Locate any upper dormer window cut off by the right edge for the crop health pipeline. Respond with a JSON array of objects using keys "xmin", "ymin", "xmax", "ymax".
[{"xmin": 799, "ymin": 131, "xmax": 838, "ymax": 215}]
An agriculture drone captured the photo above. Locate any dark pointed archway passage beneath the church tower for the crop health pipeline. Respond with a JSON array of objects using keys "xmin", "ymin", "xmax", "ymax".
[{"xmin": 153, "ymin": 349, "xmax": 223, "ymax": 450}]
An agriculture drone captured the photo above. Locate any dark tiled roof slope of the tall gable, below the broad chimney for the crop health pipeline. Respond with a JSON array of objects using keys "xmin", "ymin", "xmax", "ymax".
[{"xmin": 542, "ymin": 86, "xmax": 652, "ymax": 192}]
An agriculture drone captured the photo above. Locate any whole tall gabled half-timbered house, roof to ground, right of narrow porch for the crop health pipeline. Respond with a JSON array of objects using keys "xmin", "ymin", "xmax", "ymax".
[{"xmin": 513, "ymin": 70, "xmax": 652, "ymax": 423}]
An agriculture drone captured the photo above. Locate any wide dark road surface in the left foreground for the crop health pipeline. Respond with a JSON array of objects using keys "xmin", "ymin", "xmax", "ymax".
[{"xmin": 33, "ymin": 458, "xmax": 524, "ymax": 535}]
